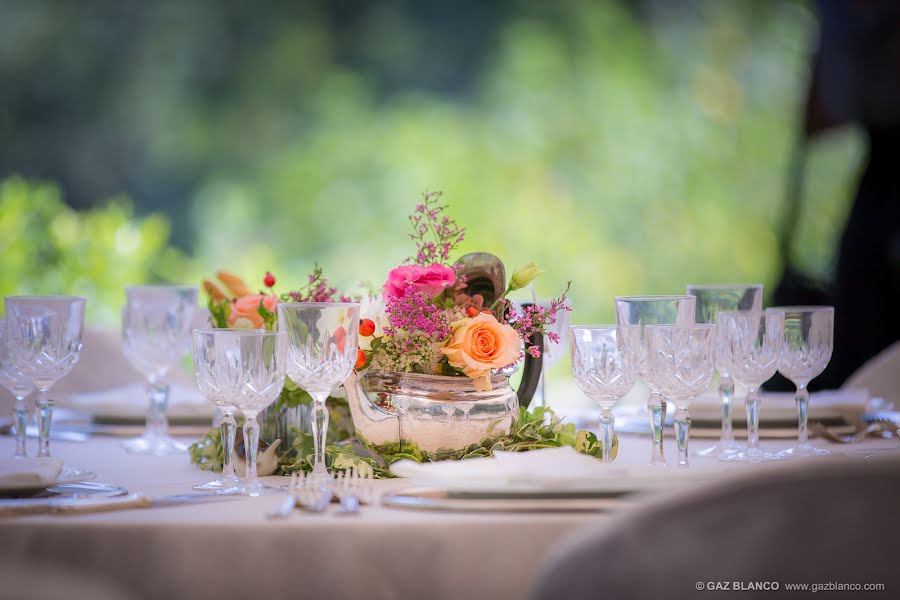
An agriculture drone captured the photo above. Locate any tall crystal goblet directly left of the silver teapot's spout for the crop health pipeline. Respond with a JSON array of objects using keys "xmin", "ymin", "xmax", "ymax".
[{"xmin": 278, "ymin": 302, "xmax": 359, "ymax": 477}]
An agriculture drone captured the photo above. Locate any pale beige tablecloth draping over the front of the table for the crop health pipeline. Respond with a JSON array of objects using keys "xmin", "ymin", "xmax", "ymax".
[{"xmin": 0, "ymin": 436, "xmax": 897, "ymax": 600}]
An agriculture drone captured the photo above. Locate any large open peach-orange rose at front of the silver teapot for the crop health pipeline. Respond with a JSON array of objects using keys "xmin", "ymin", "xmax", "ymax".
[{"xmin": 441, "ymin": 313, "xmax": 521, "ymax": 391}]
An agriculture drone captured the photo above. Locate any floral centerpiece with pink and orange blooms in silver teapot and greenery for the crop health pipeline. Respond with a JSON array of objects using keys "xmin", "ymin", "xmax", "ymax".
[{"xmin": 192, "ymin": 192, "xmax": 612, "ymax": 475}]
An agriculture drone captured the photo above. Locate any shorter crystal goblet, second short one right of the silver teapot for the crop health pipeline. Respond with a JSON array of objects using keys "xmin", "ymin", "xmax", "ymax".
[{"xmin": 644, "ymin": 324, "xmax": 716, "ymax": 467}]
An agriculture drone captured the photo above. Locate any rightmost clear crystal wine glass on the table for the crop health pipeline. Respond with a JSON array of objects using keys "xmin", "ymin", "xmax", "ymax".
[{"xmin": 769, "ymin": 306, "xmax": 834, "ymax": 457}]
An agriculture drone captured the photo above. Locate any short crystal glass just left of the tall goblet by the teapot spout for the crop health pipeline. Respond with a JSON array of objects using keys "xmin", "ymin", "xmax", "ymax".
[{"xmin": 224, "ymin": 329, "xmax": 288, "ymax": 496}]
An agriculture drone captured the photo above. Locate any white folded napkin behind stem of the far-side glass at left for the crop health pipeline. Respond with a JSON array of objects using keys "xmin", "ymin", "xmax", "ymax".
[{"xmin": 57, "ymin": 383, "xmax": 215, "ymax": 419}]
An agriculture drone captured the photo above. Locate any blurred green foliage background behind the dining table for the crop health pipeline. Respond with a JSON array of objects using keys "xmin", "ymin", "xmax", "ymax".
[{"xmin": 0, "ymin": 0, "xmax": 862, "ymax": 327}]
